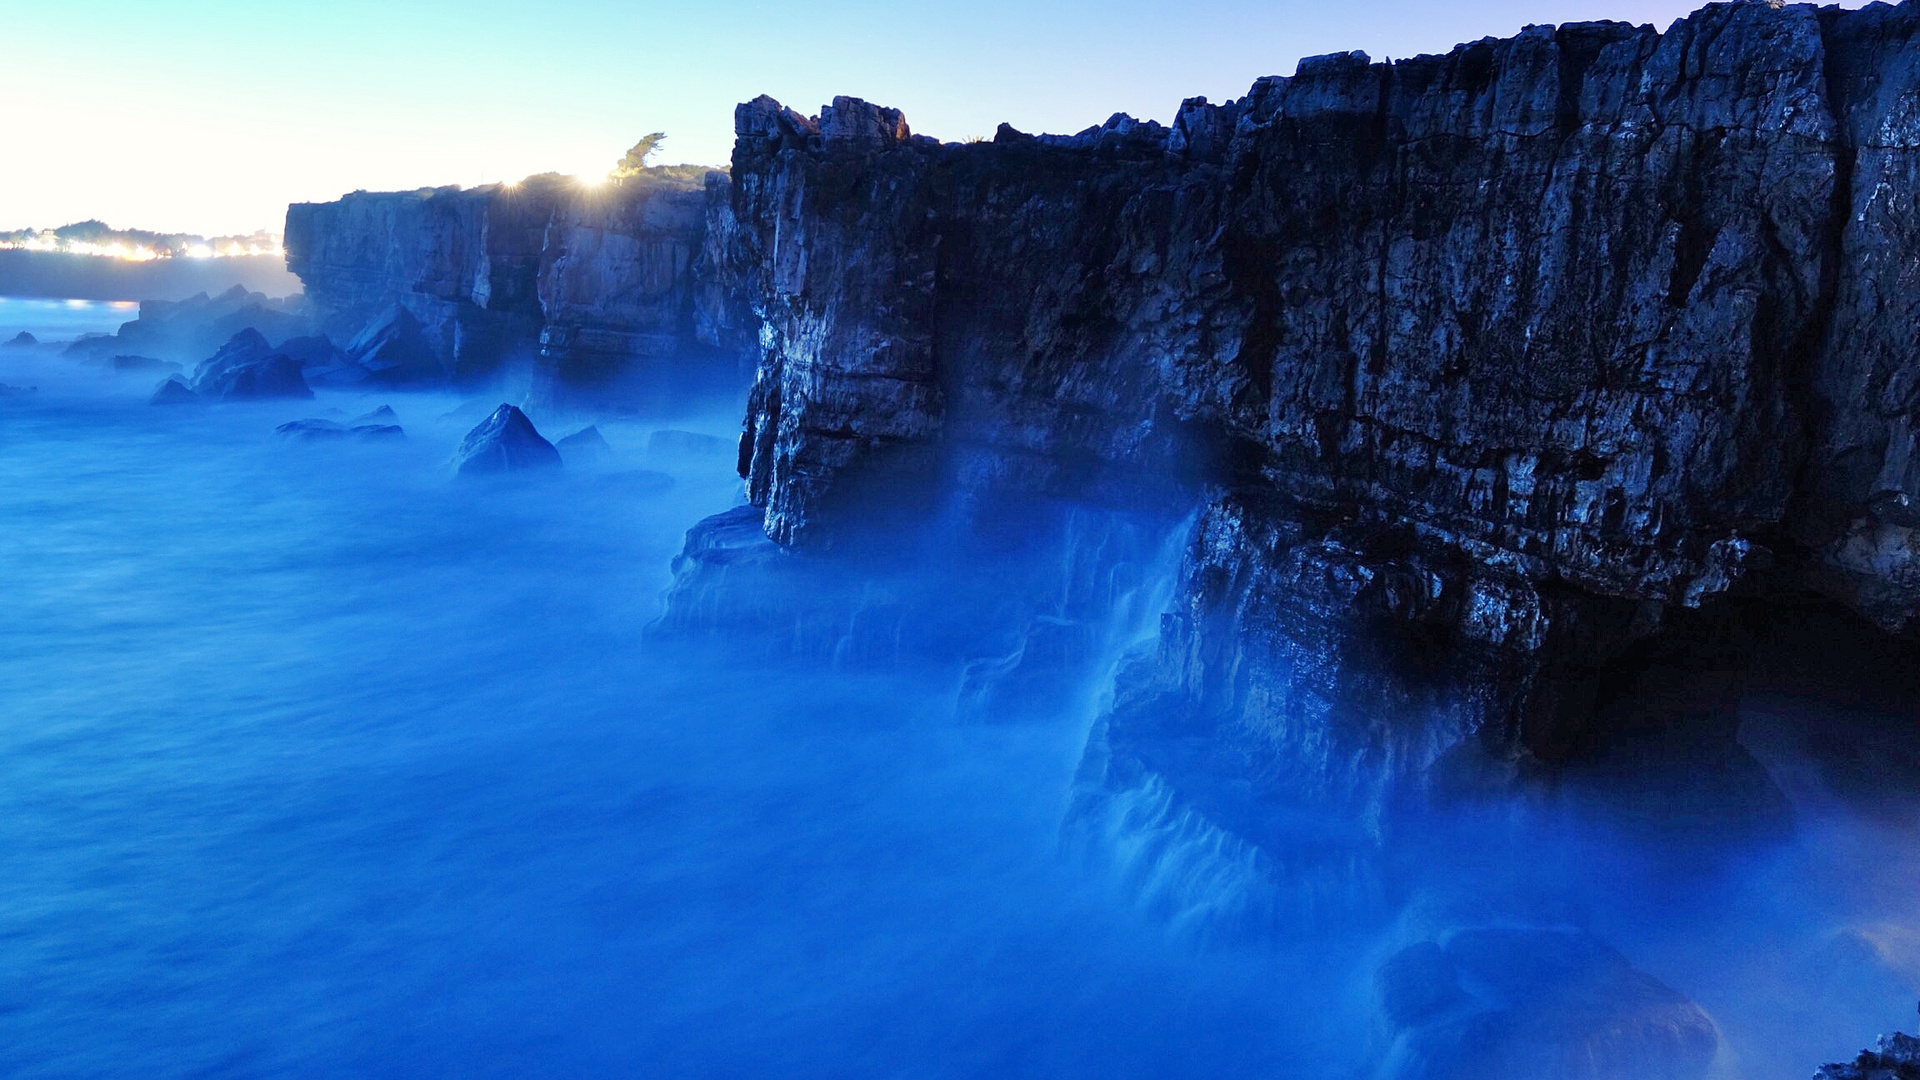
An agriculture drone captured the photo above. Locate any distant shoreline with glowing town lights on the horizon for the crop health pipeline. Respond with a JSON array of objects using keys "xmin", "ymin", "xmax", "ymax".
[{"xmin": 0, "ymin": 250, "xmax": 300, "ymax": 300}]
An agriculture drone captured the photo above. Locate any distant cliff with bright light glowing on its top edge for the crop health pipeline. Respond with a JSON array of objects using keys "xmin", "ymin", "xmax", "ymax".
[{"xmin": 286, "ymin": 167, "xmax": 741, "ymax": 405}]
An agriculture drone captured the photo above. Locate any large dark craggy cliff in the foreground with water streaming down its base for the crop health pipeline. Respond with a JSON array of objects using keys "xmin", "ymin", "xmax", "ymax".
[{"xmin": 730, "ymin": 2, "xmax": 1920, "ymax": 849}]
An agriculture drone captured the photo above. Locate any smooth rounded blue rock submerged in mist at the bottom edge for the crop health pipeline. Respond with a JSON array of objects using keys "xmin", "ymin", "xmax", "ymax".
[{"xmin": 1375, "ymin": 928, "xmax": 1720, "ymax": 1080}]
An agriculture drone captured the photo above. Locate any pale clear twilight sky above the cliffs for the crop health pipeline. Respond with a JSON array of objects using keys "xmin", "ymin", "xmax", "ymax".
[{"xmin": 0, "ymin": 0, "xmax": 1820, "ymax": 234}]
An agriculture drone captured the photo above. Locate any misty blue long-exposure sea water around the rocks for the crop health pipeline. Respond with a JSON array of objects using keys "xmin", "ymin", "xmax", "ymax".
[{"xmin": 0, "ymin": 302, "xmax": 1920, "ymax": 1078}]
